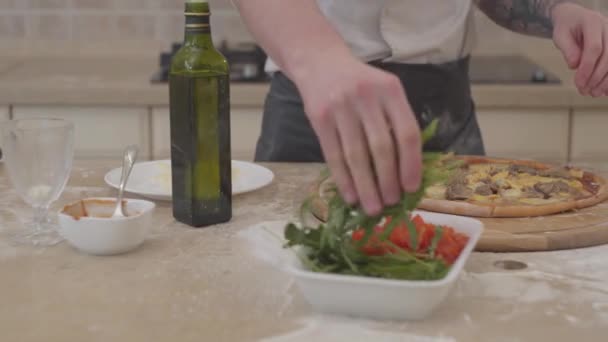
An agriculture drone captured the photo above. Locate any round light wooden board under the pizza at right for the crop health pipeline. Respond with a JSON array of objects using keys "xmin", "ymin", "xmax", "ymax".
[{"xmin": 311, "ymin": 175, "xmax": 608, "ymax": 252}]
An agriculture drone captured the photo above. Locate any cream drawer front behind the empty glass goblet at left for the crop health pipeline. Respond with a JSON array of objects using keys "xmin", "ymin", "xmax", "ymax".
[{"xmin": 13, "ymin": 106, "xmax": 150, "ymax": 159}]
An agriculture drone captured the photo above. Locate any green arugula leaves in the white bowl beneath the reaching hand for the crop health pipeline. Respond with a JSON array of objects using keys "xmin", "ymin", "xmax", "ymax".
[{"xmin": 285, "ymin": 120, "xmax": 458, "ymax": 280}]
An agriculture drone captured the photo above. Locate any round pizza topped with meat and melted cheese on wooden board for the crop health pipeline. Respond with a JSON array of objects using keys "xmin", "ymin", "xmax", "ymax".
[{"xmin": 421, "ymin": 157, "xmax": 608, "ymax": 216}]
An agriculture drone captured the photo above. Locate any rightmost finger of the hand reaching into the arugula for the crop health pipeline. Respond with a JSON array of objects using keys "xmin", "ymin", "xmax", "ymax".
[{"xmin": 383, "ymin": 77, "xmax": 422, "ymax": 192}]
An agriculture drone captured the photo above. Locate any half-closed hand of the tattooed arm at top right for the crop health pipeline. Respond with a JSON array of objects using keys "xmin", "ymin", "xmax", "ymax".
[{"xmin": 551, "ymin": 3, "xmax": 608, "ymax": 97}]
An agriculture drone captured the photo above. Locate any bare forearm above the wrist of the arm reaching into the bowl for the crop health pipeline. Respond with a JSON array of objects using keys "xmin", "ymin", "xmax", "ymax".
[{"xmin": 233, "ymin": 0, "xmax": 351, "ymax": 81}]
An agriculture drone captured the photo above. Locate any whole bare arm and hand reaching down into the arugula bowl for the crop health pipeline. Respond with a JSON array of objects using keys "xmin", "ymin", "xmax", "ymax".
[{"xmin": 235, "ymin": 0, "xmax": 422, "ymax": 215}]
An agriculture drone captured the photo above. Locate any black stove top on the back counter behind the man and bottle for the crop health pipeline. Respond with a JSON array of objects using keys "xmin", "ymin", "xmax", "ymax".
[{"xmin": 151, "ymin": 42, "xmax": 561, "ymax": 85}]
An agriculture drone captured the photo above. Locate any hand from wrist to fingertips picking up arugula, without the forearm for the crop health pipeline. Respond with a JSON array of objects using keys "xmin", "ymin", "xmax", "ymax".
[{"xmin": 296, "ymin": 56, "xmax": 422, "ymax": 215}]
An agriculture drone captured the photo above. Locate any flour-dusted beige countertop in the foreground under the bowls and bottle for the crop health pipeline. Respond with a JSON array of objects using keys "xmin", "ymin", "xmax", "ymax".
[{"xmin": 0, "ymin": 160, "xmax": 608, "ymax": 342}]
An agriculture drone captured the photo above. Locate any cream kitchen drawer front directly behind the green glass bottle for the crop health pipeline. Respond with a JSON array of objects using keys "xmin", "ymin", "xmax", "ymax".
[{"xmin": 152, "ymin": 107, "xmax": 262, "ymax": 160}]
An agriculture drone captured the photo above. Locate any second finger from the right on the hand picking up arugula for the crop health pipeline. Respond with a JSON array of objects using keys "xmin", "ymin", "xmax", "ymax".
[{"xmin": 353, "ymin": 83, "xmax": 401, "ymax": 205}]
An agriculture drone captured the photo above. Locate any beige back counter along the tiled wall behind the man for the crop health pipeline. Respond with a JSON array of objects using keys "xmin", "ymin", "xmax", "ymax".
[{"xmin": 0, "ymin": 38, "xmax": 608, "ymax": 108}]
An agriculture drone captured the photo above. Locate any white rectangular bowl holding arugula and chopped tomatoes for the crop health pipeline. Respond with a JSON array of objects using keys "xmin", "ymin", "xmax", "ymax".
[{"xmin": 286, "ymin": 211, "xmax": 483, "ymax": 320}]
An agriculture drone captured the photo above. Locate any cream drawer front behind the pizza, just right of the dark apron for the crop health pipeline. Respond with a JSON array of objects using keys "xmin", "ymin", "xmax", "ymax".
[{"xmin": 477, "ymin": 109, "xmax": 569, "ymax": 163}]
